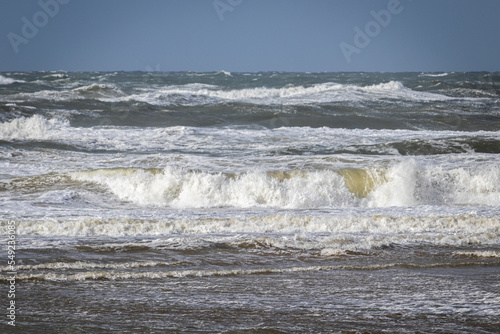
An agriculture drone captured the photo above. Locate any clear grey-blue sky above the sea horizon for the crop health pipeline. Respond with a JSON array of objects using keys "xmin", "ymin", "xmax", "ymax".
[{"xmin": 0, "ymin": 0, "xmax": 500, "ymax": 72}]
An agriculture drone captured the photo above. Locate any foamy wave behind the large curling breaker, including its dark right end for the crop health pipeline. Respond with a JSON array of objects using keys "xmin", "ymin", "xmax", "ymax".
[{"xmin": 0, "ymin": 116, "xmax": 500, "ymax": 156}]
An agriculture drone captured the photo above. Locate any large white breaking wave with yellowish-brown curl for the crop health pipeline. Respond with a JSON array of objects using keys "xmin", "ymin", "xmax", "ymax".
[{"xmin": 65, "ymin": 159, "xmax": 500, "ymax": 209}]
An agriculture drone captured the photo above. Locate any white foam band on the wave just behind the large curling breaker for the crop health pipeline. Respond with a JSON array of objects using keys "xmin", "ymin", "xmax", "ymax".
[{"xmin": 0, "ymin": 116, "xmax": 500, "ymax": 155}]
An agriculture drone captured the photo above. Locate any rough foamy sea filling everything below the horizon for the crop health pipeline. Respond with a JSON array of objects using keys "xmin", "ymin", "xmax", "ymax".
[{"xmin": 0, "ymin": 71, "xmax": 500, "ymax": 333}]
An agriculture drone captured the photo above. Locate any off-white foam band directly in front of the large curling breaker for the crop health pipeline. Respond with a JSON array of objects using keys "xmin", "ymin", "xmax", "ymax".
[{"xmin": 8, "ymin": 214, "xmax": 500, "ymax": 250}]
